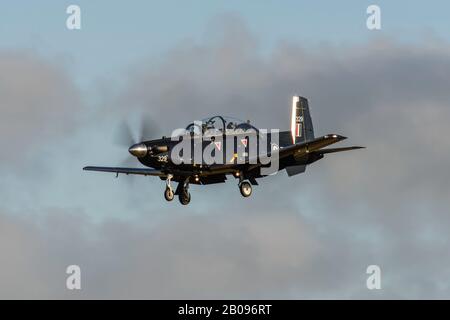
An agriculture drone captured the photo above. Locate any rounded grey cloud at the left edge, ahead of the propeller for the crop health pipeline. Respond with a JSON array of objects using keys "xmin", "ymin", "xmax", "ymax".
[{"xmin": 0, "ymin": 50, "xmax": 81, "ymax": 163}]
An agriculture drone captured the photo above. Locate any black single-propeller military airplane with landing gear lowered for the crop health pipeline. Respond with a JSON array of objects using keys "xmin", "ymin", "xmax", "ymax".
[{"xmin": 83, "ymin": 96, "xmax": 364, "ymax": 205}]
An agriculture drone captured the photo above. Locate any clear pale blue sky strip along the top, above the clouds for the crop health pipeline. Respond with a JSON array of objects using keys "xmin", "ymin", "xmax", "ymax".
[{"xmin": 0, "ymin": 0, "xmax": 450, "ymax": 85}]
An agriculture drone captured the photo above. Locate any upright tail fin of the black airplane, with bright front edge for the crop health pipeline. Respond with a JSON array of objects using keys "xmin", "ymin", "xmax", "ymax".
[{"xmin": 291, "ymin": 96, "xmax": 314, "ymax": 143}]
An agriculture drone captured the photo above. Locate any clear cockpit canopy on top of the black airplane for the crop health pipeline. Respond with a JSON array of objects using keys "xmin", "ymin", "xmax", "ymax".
[{"xmin": 186, "ymin": 116, "xmax": 258, "ymax": 135}]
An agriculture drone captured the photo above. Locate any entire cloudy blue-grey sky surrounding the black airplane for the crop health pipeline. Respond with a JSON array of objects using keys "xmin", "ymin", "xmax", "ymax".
[{"xmin": 0, "ymin": 0, "xmax": 450, "ymax": 299}]
